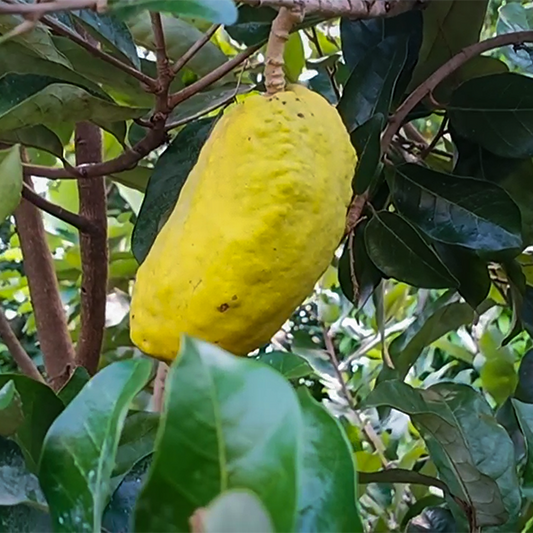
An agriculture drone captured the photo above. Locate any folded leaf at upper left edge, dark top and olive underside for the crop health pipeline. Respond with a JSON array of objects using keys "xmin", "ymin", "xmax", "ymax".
[{"xmin": 0, "ymin": 74, "xmax": 146, "ymax": 138}]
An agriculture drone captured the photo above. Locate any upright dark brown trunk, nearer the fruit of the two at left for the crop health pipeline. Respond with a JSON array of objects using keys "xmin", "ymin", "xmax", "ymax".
[{"xmin": 75, "ymin": 122, "xmax": 108, "ymax": 375}]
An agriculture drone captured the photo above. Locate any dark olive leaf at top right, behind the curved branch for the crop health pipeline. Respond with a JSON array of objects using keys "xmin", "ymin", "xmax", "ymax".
[{"xmin": 408, "ymin": 0, "xmax": 488, "ymax": 97}]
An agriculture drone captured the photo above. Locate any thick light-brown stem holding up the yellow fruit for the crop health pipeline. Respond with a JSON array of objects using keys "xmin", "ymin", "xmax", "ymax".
[{"xmin": 265, "ymin": 6, "xmax": 304, "ymax": 95}]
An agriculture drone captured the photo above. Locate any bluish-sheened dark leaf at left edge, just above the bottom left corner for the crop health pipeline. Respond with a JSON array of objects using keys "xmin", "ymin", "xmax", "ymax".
[{"xmin": 0, "ymin": 437, "xmax": 46, "ymax": 508}]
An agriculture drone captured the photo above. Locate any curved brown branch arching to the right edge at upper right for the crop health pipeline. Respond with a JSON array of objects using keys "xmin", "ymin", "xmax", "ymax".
[{"xmin": 381, "ymin": 31, "xmax": 533, "ymax": 153}]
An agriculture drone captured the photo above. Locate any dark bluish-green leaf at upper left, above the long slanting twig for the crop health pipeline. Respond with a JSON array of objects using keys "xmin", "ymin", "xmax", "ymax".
[{"xmin": 72, "ymin": 9, "xmax": 141, "ymax": 69}]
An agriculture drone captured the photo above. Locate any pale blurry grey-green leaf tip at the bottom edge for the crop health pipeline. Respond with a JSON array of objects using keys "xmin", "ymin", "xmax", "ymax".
[{"xmin": 197, "ymin": 489, "xmax": 275, "ymax": 533}]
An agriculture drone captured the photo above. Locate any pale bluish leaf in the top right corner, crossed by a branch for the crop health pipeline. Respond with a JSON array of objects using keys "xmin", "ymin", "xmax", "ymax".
[{"xmin": 496, "ymin": 2, "xmax": 533, "ymax": 74}]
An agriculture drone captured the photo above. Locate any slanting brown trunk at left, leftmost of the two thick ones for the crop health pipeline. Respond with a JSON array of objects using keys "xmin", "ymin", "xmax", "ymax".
[{"xmin": 14, "ymin": 176, "xmax": 74, "ymax": 390}]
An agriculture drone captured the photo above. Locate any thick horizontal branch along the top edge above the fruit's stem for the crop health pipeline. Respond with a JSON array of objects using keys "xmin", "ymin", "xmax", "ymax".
[{"xmin": 241, "ymin": 0, "xmax": 430, "ymax": 19}]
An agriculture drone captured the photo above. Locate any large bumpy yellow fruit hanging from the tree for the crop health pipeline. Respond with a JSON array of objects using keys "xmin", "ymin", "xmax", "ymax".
[{"xmin": 130, "ymin": 86, "xmax": 357, "ymax": 360}]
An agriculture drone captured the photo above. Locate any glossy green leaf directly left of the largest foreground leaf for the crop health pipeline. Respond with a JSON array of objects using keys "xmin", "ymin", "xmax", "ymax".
[{"xmin": 39, "ymin": 359, "xmax": 152, "ymax": 533}]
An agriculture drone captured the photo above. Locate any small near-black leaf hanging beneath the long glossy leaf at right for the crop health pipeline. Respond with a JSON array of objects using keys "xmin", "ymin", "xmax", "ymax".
[{"xmin": 435, "ymin": 243, "xmax": 491, "ymax": 309}]
